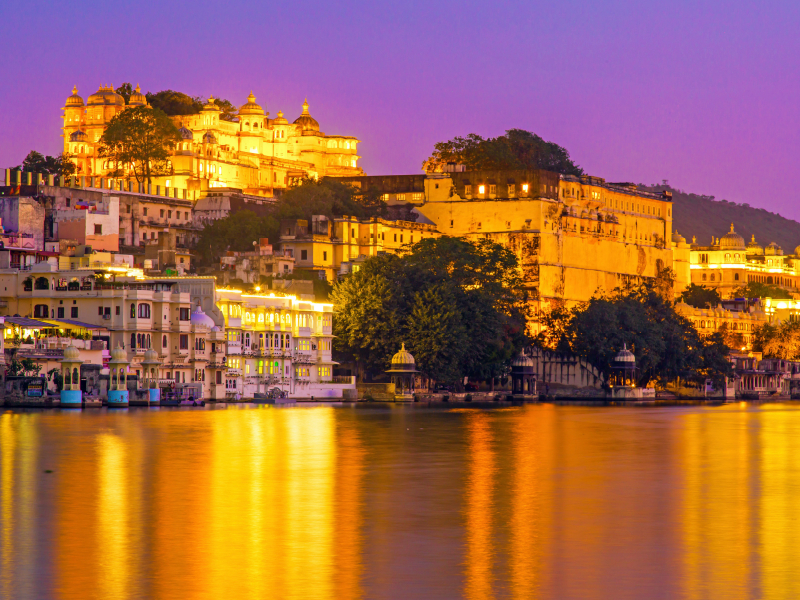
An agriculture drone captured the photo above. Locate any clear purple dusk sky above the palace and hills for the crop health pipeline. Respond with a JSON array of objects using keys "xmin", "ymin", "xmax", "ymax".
[{"xmin": 0, "ymin": 0, "xmax": 800, "ymax": 219}]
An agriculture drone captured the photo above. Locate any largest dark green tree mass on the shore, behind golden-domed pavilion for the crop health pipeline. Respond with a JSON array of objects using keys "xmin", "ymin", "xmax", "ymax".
[{"xmin": 331, "ymin": 237, "xmax": 527, "ymax": 382}]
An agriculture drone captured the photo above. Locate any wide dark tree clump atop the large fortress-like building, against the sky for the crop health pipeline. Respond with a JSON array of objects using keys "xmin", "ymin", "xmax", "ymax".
[{"xmin": 422, "ymin": 129, "xmax": 583, "ymax": 175}]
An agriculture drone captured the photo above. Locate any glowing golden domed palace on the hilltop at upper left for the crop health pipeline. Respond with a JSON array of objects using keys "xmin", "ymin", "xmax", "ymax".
[{"xmin": 62, "ymin": 85, "xmax": 363, "ymax": 196}]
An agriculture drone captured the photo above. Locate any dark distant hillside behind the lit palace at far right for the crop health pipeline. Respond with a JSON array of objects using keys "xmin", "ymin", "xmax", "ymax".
[{"xmin": 639, "ymin": 185, "xmax": 800, "ymax": 248}]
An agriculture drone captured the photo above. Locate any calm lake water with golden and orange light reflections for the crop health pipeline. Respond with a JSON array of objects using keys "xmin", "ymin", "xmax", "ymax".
[{"xmin": 0, "ymin": 404, "xmax": 800, "ymax": 600}]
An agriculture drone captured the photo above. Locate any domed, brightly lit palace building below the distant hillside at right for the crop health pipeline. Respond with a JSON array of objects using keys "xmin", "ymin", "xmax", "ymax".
[{"xmin": 690, "ymin": 224, "xmax": 800, "ymax": 298}]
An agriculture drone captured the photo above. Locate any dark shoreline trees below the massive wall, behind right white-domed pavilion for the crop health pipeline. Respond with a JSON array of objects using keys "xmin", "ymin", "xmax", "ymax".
[{"xmin": 536, "ymin": 281, "xmax": 731, "ymax": 386}]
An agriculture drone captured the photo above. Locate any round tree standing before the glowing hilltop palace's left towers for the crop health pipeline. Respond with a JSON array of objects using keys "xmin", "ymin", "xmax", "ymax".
[{"xmin": 98, "ymin": 106, "xmax": 180, "ymax": 183}]
